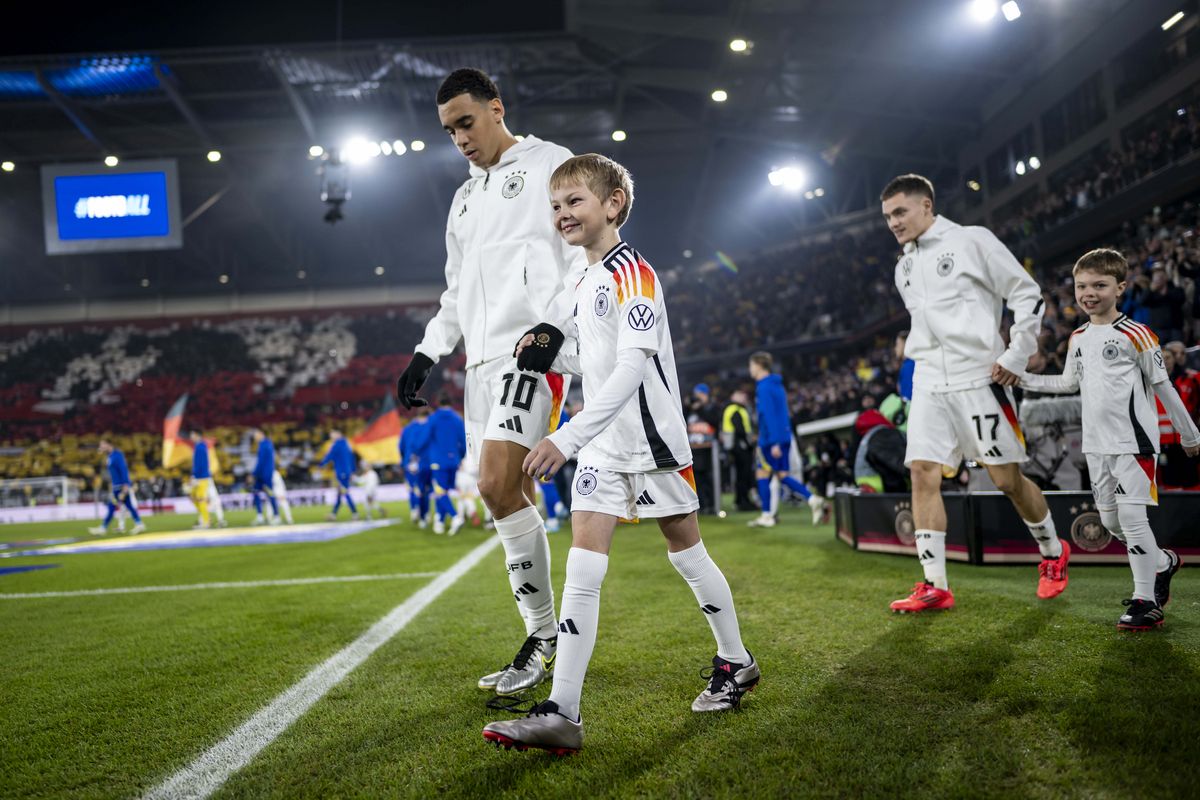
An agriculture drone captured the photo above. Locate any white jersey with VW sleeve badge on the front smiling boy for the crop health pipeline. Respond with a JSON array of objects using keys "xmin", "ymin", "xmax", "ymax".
[{"xmin": 564, "ymin": 242, "xmax": 691, "ymax": 473}]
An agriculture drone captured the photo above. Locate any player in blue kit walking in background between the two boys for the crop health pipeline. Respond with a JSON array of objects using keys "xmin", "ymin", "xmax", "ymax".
[{"xmin": 750, "ymin": 353, "xmax": 824, "ymax": 528}]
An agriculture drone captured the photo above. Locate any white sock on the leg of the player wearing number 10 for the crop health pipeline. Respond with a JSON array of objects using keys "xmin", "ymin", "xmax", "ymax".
[{"xmin": 496, "ymin": 506, "xmax": 558, "ymax": 639}]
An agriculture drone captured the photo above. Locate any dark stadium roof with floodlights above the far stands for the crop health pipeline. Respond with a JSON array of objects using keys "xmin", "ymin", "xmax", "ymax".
[{"xmin": 0, "ymin": 0, "xmax": 1128, "ymax": 302}]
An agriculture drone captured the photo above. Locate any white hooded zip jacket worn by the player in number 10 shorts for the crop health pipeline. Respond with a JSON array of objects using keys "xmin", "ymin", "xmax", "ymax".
[{"xmin": 416, "ymin": 136, "xmax": 587, "ymax": 367}]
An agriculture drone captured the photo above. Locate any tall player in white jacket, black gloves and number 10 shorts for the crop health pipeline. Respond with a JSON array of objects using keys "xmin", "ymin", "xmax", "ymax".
[{"xmin": 396, "ymin": 70, "xmax": 587, "ymax": 694}]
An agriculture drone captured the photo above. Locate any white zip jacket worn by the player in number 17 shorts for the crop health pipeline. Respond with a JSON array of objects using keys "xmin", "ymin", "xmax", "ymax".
[{"xmin": 895, "ymin": 216, "xmax": 1043, "ymax": 392}]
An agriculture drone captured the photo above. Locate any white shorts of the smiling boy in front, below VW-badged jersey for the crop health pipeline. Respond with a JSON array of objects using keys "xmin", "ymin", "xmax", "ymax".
[{"xmin": 571, "ymin": 464, "xmax": 700, "ymax": 519}]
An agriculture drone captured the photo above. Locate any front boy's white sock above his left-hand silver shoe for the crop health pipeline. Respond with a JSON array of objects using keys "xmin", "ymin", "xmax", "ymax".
[{"xmin": 550, "ymin": 547, "xmax": 608, "ymax": 720}]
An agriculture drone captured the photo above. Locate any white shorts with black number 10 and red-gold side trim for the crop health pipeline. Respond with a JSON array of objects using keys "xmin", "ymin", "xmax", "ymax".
[{"xmin": 463, "ymin": 359, "xmax": 570, "ymax": 464}]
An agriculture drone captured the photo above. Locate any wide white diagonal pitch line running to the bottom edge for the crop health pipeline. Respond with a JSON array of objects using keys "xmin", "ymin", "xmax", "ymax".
[{"xmin": 145, "ymin": 536, "xmax": 500, "ymax": 800}]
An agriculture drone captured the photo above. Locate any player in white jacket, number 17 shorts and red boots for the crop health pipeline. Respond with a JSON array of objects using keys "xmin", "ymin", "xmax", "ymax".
[{"xmin": 880, "ymin": 175, "xmax": 1070, "ymax": 613}]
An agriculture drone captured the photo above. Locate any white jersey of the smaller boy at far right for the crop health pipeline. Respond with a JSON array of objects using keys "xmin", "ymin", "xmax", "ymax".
[{"xmin": 1021, "ymin": 314, "xmax": 1170, "ymax": 456}]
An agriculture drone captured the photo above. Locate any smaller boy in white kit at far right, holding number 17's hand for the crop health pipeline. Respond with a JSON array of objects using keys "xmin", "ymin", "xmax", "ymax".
[{"xmin": 1021, "ymin": 248, "xmax": 1200, "ymax": 631}]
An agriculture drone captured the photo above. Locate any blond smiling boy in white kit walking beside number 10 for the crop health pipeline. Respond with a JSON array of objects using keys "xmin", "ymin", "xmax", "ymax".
[{"xmin": 484, "ymin": 154, "xmax": 760, "ymax": 754}]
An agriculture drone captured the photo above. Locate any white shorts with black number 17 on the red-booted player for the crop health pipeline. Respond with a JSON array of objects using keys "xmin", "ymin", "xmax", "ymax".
[{"xmin": 904, "ymin": 384, "xmax": 1025, "ymax": 467}]
